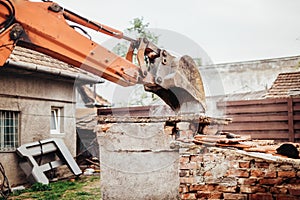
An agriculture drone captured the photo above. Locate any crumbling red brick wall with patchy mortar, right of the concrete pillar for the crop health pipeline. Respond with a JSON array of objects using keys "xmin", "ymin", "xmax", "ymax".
[{"xmin": 179, "ymin": 145, "xmax": 300, "ymax": 200}]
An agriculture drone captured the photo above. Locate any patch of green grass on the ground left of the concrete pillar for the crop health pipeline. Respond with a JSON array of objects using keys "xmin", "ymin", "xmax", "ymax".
[{"xmin": 8, "ymin": 176, "xmax": 101, "ymax": 200}]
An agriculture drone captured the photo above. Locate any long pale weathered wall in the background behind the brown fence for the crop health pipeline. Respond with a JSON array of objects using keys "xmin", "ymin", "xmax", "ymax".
[{"xmin": 199, "ymin": 56, "xmax": 300, "ymax": 96}]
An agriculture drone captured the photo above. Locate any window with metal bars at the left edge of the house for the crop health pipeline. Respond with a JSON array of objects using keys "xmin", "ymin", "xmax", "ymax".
[{"xmin": 0, "ymin": 110, "xmax": 19, "ymax": 151}]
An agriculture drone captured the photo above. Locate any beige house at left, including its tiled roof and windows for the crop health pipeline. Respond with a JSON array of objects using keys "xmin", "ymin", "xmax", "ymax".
[{"xmin": 0, "ymin": 47, "xmax": 101, "ymax": 186}]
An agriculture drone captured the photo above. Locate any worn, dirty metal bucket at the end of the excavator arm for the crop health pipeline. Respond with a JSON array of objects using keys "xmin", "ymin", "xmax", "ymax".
[{"xmin": 144, "ymin": 50, "xmax": 206, "ymax": 113}]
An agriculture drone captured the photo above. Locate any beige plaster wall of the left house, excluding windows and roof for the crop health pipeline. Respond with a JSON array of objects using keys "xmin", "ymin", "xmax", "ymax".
[{"xmin": 0, "ymin": 73, "xmax": 76, "ymax": 185}]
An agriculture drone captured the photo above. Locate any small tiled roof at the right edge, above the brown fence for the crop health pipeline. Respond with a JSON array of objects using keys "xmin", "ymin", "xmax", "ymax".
[{"xmin": 266, "ymin": 71, "xmax": 300, "ymax": 98}]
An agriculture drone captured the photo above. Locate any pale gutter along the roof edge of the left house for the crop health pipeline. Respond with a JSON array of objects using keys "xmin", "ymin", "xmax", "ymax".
[{"xmin": 6, "ymin": 60, "xmax": 104, "ymax": 84}]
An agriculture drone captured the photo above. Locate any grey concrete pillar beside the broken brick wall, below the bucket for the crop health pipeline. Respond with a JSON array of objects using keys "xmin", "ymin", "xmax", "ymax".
[{"xmin": 97, "ymin": 122, "xmax": 179, "ymax": 200}]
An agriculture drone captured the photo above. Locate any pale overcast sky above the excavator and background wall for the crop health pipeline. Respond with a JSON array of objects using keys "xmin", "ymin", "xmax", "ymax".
[{"xmin": 56, "ymin": 0, "xmax": 300, "ymax": 63}]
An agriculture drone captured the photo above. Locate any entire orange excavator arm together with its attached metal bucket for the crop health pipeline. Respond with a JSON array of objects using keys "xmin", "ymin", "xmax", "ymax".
[{"xmin": 0, "ymin": 0, "xmax": 205, "ymax": 110}]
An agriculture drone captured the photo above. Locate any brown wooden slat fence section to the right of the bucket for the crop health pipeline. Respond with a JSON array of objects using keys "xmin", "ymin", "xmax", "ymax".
[{"xmin": 217, "ymin": 98, "xmax": 300, "ymax": 142}]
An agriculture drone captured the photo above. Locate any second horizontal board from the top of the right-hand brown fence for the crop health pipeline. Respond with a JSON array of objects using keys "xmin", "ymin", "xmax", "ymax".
[{"xmin": 225, "ymin": 104, "xmax": 287, "ymax": 115}]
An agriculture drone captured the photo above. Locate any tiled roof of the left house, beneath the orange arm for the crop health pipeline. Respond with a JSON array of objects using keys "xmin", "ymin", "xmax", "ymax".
[{"xmin": 8, "ymin": 46, "xmax": 103, "ymax": 83}]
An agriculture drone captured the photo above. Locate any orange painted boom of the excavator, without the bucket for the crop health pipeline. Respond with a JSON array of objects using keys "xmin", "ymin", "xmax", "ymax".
[{"xmin": 0, "ymin": 0, "xmax": 139, "ymax": 86}]
